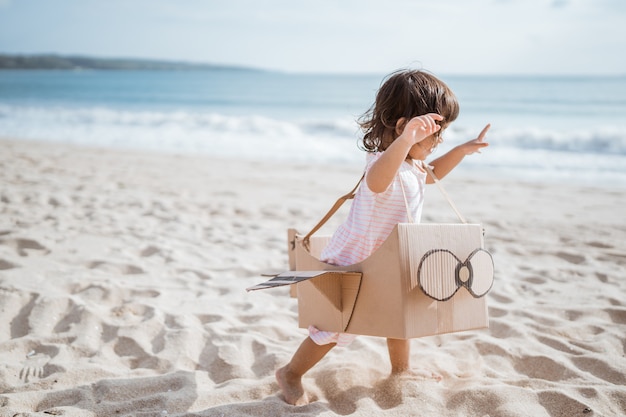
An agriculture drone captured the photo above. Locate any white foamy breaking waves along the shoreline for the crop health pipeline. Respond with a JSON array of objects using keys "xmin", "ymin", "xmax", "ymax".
[{"xmin": 0, "ymin": 104, "xmax": 626, "ymax": 184}]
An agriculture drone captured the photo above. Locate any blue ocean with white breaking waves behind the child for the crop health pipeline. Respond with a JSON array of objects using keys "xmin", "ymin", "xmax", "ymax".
[{"xmin": 0, "ymin": 69, "xmax": 626, "ymax": 187}]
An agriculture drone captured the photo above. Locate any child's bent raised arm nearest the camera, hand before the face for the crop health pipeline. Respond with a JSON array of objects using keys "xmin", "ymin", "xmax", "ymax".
[{"xmin": 365, "ymin": 113, "xmax": 443, "ymax": 193}]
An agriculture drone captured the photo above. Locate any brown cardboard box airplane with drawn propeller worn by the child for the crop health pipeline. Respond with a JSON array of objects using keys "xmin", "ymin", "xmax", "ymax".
[{"xmin": 249, "ymin": 223, "xmax": 494, "ymax": 339}]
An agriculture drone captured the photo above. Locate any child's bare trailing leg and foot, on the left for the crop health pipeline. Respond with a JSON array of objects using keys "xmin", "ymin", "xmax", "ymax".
[{"xmin": 276, "ymin": 337, "xmax": 335, "ymax": 405}]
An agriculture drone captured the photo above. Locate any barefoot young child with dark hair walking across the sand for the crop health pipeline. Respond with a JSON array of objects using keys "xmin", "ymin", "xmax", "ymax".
[{"xmin": 276, "ymin": 70, "xmax": 489, "ymax": 405}]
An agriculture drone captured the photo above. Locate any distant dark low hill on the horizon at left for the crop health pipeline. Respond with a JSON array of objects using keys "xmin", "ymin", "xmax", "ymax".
[{"xmin": 0, "ymin": 54, "xmax": 259, "ymax": 71}]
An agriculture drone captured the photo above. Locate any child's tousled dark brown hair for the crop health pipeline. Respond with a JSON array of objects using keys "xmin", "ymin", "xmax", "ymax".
[{"xmin": 359, "ymin": 70, "xmax": 459, "ymax": 152}]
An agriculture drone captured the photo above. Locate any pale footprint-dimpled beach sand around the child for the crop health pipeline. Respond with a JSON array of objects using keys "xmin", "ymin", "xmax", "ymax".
[{"xmin": 0, "ymin": 140, "xmax": 626, "ymax": 417}]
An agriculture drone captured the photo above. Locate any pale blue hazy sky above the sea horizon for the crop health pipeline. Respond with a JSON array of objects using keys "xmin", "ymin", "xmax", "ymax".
[{"xmin": 0, "ymin": 0, "xmax": 626, "ymax": 75}]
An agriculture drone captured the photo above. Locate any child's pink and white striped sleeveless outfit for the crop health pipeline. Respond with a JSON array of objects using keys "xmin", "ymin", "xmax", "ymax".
[{"xmin": 309, "ymin": 152, "xmax": 426, "ymax": 346}]
